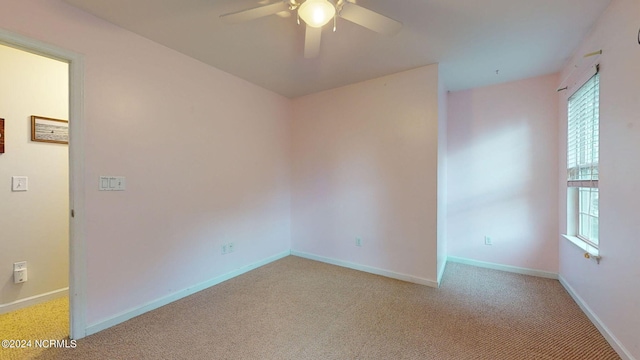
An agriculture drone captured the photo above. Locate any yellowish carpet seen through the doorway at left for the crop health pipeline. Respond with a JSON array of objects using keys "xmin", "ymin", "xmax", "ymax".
[{"xmin": 0, "ymin": 296, "xmax": 69, "ymax": 360}]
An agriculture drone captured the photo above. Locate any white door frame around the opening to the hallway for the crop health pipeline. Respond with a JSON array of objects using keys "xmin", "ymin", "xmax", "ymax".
[{"xmin": 0, "ymin": 29, "xmax": 87, "ymax": 339}]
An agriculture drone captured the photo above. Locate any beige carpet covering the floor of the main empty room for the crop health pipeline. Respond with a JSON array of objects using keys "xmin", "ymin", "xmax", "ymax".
[{"xmin": 40, "ymin": 256, "xmax": 619, "ymax": 360}]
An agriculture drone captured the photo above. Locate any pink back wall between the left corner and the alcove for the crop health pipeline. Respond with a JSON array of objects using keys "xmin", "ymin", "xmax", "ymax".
[{"xmin": 292, "ymin": 65, "xmax": 438, "ymax": 281}]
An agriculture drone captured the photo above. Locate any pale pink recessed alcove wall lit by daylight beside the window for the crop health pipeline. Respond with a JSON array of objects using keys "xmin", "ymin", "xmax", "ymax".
[{"xmin": 447, "ymin": 75, "xmax": 559, "ymax": 272}]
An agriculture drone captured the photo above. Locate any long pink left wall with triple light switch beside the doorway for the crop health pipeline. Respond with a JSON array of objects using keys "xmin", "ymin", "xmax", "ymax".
[{"xmin": 0, "ymin": 0, "xmax": 290, "ymax": 326}]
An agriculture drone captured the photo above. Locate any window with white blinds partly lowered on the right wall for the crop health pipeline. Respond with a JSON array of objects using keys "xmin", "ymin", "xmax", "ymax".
[{"xmin": 567, "ymin": 71, "xmax": 600, "ymax": 250}]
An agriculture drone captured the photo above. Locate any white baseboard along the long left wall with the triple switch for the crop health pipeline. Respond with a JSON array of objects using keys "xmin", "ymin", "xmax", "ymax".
[{"xmin": 86, "ymin": 251, "xmax": 291, "ymax": 336}]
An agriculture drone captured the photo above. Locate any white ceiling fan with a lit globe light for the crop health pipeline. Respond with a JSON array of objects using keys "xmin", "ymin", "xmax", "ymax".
[{"xmin": 220, "ymin": 0, "xmax": 402, "ymax": 58}]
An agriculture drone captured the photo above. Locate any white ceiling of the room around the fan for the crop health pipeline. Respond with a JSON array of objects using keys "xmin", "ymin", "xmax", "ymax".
[{"xmin": 65, "ymin": 0, "xmax": 611, "ymax": 98}]
